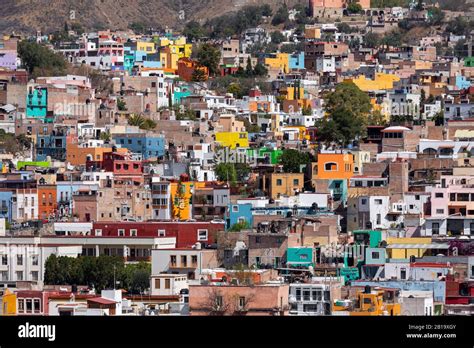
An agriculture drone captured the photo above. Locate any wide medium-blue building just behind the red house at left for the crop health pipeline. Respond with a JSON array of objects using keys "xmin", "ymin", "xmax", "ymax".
[{"xmin": 113, "ymin": 133, "xmax": 165, "ymax": 160}]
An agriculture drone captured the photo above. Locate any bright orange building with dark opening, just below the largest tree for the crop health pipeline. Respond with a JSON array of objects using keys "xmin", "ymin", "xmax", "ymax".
[{"xmin": 313, "ymin": 153, "xmax": 354, "ymax": 180}]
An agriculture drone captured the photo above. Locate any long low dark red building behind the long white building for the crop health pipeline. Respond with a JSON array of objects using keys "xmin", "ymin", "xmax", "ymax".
[{"xmin": 91, "ymin": 221, "xmax": 225, "ymax": 248}]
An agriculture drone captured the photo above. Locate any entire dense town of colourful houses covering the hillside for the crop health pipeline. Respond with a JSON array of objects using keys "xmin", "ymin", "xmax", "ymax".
[{"xmin": 0, "ymin": 0, "xmax": 474, "ymax": 316}]
